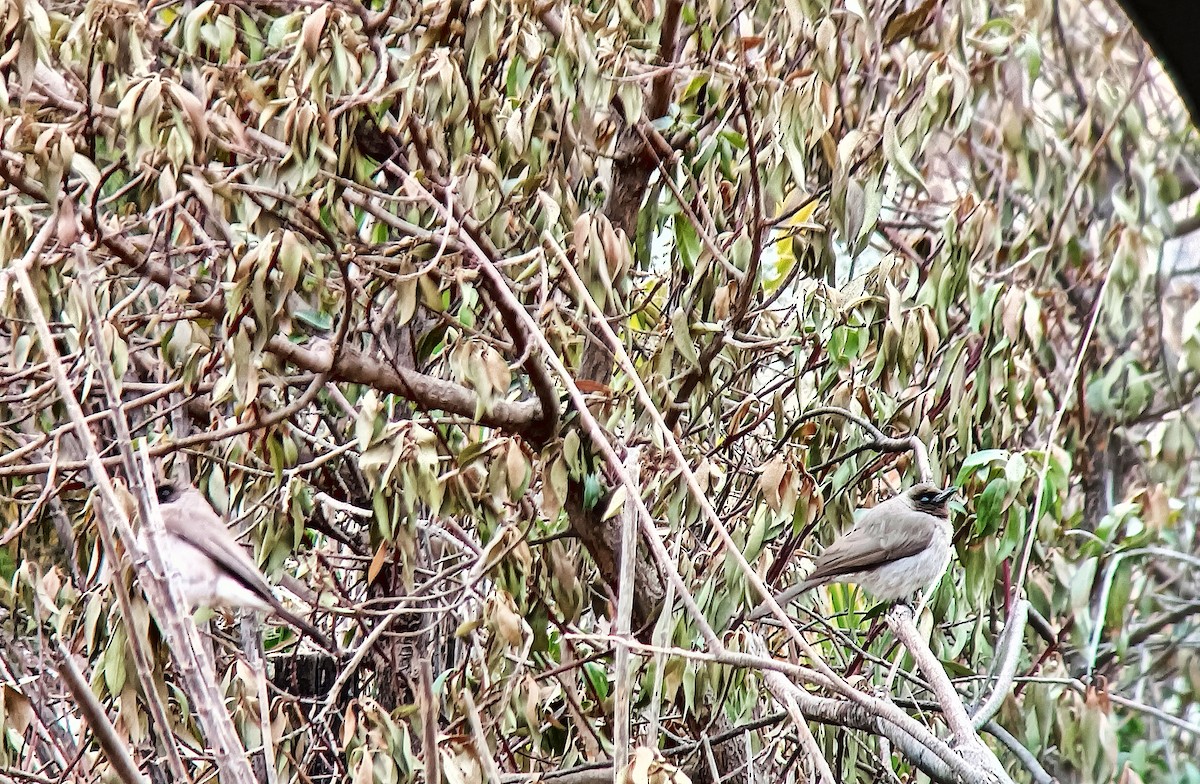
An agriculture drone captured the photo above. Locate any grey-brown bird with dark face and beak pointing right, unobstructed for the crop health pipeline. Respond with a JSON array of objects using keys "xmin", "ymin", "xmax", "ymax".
[{"xmin": 746, "ymin": 483, "xmax": 956, "ymax": 621}]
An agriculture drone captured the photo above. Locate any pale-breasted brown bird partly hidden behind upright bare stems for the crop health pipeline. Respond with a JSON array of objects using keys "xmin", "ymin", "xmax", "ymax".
[{"xmin": 139, "ymin": 484, "xmax": 335, "ymax": 651}]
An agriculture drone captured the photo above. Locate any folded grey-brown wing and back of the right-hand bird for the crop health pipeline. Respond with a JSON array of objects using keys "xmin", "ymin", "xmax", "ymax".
[{"xmin": 804, "ymin": 502, "xmax": 937, "ymax": 586}]
